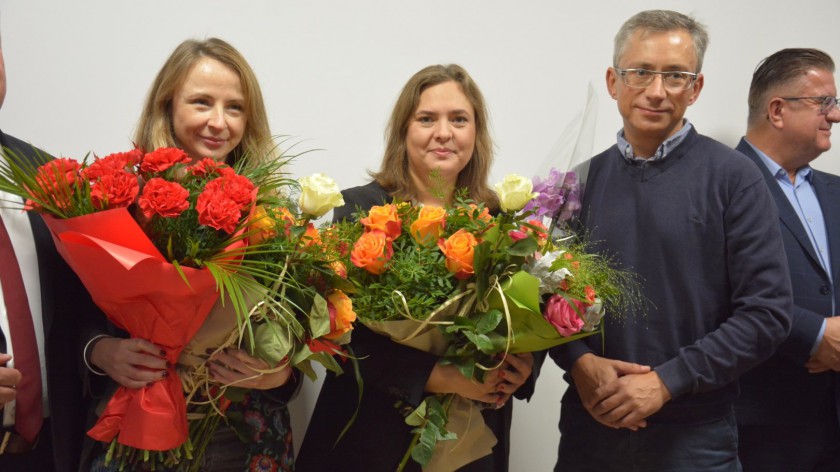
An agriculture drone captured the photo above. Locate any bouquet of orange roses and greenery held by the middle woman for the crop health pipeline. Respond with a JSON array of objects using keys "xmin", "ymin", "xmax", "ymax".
[{"xmin": 324, "ymin": 176, "xmax": 626, "ymax": 470}]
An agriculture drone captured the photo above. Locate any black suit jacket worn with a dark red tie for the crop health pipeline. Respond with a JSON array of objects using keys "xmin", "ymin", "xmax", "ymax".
[{"xmin": 0, "ymin": 131, "xmax": 104, "ymax": 472}]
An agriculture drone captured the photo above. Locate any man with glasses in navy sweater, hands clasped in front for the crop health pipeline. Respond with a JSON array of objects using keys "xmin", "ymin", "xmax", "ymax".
[{"xmin": 551, "ymin": 11, "xmax": 792, "ymax": 472}]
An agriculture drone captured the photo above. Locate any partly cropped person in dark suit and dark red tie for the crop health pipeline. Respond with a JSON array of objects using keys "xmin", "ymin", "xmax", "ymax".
[{"xmin": 0, "ymin": 32, "xmax": 104, "ymax": 472}]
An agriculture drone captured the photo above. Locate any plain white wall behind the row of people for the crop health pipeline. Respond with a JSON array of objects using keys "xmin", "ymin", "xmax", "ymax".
[{"xmin": 0, "ymin": 0, "xmax": 840, "ymax": 472}]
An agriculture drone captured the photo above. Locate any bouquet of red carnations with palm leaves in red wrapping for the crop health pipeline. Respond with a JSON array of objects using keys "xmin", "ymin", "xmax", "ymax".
[{"xmin": 0, "ymin": 148, "xmax": 308, "ymax": 464}]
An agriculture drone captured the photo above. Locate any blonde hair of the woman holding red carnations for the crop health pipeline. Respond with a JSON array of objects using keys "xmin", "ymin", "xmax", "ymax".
[{"xmin": 134, "ymin": 38, "xmax": 274, "ymax": 164}]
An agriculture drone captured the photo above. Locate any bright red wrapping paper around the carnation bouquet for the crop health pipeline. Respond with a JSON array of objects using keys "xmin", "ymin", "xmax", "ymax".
[{"xmin": 44, "ymin": 208, "xmax": 218, "ymax": 451}]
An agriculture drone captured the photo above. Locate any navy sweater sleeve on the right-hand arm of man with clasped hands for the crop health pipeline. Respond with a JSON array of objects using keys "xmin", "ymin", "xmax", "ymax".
[{"xmin": 655, "ymin": 169, "xmax": 793, "ymax": 398}]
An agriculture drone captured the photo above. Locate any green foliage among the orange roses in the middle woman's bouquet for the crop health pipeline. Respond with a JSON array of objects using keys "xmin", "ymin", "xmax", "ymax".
[{"xmin": 328, "ymin": 191, "xmax": 640, "ymax": 470}]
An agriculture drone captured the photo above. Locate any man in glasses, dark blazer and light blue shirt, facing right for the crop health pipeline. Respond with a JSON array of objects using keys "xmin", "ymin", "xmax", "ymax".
[{"xmin": 735, "ymin": 49, "xmax": 840, "ymax": 472}]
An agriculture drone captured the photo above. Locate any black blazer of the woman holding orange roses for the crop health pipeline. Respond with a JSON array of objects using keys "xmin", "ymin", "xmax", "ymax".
[{"xmin": 296, "ymin": 182, "xmax": 543, "ymax": 472}]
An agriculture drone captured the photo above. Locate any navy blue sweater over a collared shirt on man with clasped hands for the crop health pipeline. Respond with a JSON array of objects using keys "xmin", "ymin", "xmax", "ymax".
[{"xmin": 552, "ymin": 129, "xmax": 792, "ymax": 422}]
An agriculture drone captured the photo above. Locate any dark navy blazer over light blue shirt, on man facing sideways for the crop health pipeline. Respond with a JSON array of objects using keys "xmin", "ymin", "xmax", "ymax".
[{"xmin": 736, "ymin": 139, "xmax": 840, "ymax": 425}]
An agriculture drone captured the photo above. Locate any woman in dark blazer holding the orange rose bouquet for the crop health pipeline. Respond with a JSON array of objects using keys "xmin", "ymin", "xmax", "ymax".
[{"xmin": 297, "ymin": 65, "xmax": 535, "ymax": 472}]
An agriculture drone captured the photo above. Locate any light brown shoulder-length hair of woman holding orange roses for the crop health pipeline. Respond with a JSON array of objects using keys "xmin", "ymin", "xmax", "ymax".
[{"xmin": 370, "ymin": 64, "xmax": 499, "ymax": 209}]
